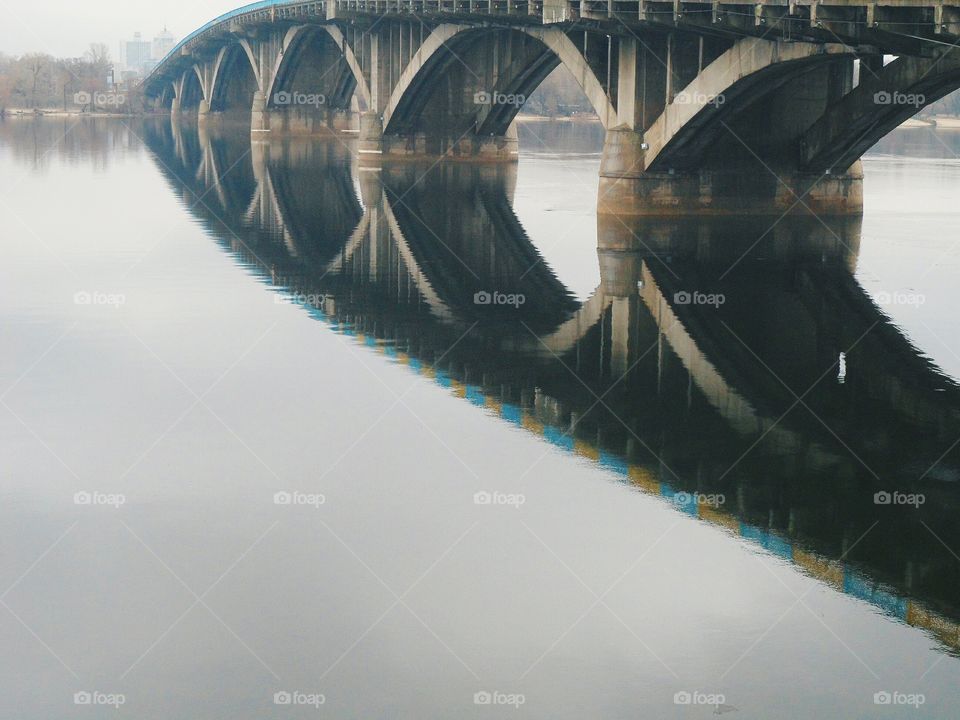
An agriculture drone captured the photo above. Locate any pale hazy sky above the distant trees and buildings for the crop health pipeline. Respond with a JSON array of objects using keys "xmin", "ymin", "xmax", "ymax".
[{"xmin": 0, "ymin": 0, "xmax": 239, "ymax": 60}]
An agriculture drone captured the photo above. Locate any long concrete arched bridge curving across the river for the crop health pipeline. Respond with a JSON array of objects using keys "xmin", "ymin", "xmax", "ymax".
[{"xmin": 144, "ymin": 0, "xmax": 960, "ymax": 215}]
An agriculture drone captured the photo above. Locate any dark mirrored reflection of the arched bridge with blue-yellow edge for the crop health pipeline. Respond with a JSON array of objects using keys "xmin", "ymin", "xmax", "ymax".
[{"xmin": 146, "ymin": 121, "xmax": 960, "ymax": 653}]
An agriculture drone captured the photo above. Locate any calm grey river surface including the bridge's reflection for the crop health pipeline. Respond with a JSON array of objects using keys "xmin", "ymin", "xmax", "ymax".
[{"xmin": 0, "ymin": 115, "xmax": 960, "ymax": 720}]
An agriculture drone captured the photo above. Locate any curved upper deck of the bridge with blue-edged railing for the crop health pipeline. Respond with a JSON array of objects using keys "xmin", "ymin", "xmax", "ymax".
[{"xmin": 144, "ymin": 0, "xmax": 960, "ymax": 85}]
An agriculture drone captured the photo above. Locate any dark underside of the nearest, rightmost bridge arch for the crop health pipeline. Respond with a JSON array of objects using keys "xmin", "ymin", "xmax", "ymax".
[{"xmin": 644, "ymin": 40, "xmax": 960, "ymax": 174}]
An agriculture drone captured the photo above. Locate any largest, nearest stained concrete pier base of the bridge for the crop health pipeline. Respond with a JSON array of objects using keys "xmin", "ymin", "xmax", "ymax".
[{"xmin": 597, "ymin": 130, "xmax": 863, "ymax": 216}]
